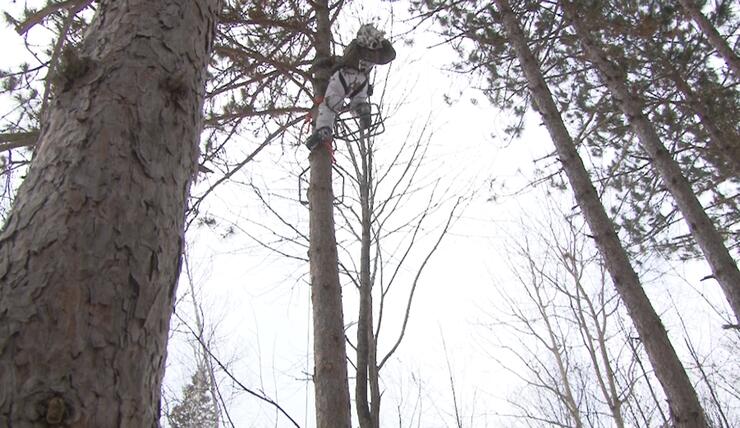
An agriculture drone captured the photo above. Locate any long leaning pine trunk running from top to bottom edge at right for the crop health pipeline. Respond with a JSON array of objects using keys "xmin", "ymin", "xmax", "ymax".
[{"xmin": 495, "ymin": 0, "xmax": 706, "ymax": 428}]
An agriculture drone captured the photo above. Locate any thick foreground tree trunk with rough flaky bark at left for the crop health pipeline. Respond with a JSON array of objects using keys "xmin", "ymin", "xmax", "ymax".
[{"xmin": 0, "ymin": 0, "xmax": 220, "ymax": 427}]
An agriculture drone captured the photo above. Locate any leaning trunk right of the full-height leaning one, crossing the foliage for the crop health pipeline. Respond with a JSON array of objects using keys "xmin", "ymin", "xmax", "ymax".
[{"xmin": 561, "ymin": 1, "xmax": 740, "ymax": 324}]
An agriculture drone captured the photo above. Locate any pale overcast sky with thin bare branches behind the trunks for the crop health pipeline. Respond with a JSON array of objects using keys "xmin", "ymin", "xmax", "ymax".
[{"xmin": 0, "ymin": 1, "xmax": 740, "ymax": 427}]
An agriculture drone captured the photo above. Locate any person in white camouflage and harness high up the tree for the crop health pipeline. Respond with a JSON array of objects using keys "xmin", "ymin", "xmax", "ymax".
[{"xmin": 306, "ymin": 24, "xmax": 396, "ymax": 150}]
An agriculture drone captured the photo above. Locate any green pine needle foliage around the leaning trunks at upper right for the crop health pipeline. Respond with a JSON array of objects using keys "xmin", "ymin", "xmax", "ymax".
[{"xmin": 414, "ymin": 0, "xmax": 740, "ymax": 258}]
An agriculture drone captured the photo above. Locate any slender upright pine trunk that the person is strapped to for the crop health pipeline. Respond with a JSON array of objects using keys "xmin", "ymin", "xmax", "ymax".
[{"xmin": 308, "ymin": 0, "xmax": 351, "ymax": 428}]
